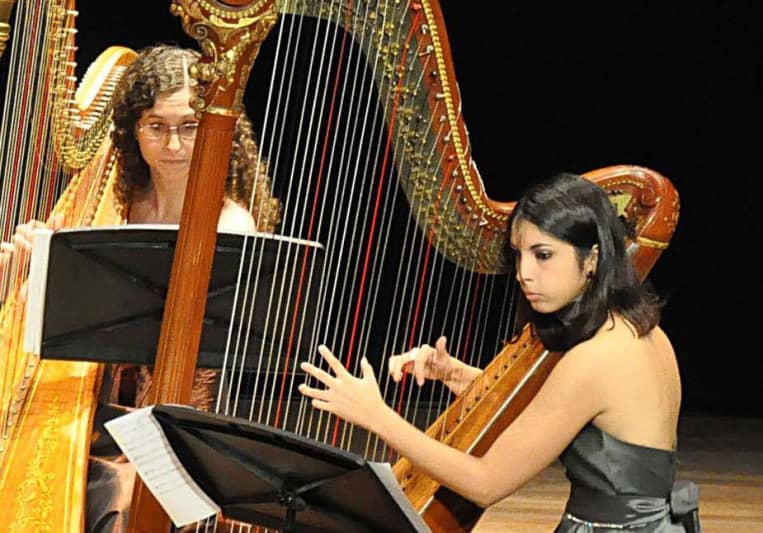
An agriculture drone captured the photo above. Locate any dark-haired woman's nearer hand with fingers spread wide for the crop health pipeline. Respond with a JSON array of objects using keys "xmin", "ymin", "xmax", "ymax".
[{"xmin": 299, "ymin": 345, "xmax": 387, "ymax": 431}]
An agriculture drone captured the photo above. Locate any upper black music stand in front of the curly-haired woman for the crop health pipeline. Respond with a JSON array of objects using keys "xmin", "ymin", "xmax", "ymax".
[{"xmin": 26, "ymin": 225, "xmax": 324, "ymax": 370}]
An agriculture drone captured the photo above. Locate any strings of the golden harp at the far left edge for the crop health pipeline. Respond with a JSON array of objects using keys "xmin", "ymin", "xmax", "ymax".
[{"xmin": 0, "ymin": 1, "xmax": 75, "ymax": 438}]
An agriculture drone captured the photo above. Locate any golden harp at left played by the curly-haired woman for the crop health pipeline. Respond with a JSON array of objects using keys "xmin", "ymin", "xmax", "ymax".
[{"xmin": 0, "ymin": 0, "xmax": 134, "ymax": 531}]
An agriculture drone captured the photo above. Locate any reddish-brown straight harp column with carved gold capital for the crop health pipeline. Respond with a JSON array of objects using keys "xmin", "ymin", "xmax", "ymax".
[{"xmin": 129, "ymin": 0, "xmax": 277, "ymax": 533}]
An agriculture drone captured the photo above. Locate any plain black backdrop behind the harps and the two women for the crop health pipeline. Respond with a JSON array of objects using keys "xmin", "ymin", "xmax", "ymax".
[{"xmin": 3, "ymin": 0, "xmax": 763, "ymax": 416}]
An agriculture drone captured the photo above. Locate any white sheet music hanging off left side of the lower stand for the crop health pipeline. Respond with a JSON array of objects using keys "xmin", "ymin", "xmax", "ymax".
[{"xmin": 104, "ymin": 406, "xmax": 220, "ymax": 527}]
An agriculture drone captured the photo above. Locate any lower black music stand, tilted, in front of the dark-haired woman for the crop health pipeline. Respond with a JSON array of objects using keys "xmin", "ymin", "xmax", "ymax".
[{"xmin": 152, "ymin": 405, "xmax": 429, "ymax": 533}]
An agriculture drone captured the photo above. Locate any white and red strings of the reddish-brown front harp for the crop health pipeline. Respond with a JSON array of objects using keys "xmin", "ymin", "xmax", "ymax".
[{"xmin": 216, "ymin": 2, "xmax": 510, "ymax": 460}]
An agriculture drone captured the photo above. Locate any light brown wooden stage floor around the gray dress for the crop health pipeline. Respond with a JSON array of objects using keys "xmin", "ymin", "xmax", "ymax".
[{"xmin": 474, "ymin": 416, "xmax": 763, "ymax": 533}]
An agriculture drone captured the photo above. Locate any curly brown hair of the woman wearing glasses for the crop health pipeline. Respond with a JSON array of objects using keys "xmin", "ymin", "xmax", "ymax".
[{"xmin": 111, "ymin": 45, "xmax": 281, "ymax": 231}]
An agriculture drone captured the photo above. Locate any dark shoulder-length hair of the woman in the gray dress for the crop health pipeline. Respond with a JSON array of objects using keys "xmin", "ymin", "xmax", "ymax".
[{"xmin": 506, "ymin": 173, "xmax": 663, "ymax": 351}]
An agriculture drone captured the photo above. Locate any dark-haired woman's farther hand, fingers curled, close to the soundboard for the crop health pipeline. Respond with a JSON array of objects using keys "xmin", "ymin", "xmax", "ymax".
[{"xmin": 388, "ymin": 336, "xmax": 480, "ymax": 394}]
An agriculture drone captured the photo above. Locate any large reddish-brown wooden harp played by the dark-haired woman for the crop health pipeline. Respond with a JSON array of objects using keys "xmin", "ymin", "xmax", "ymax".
[{"xmin": 131, "ymin": 0, "xmax": 678, "ymax": 531}]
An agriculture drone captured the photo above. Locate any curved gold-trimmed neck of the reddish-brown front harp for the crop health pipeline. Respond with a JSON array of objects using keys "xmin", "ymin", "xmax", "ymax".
[{"xmin": 255, "ymin": 0, "xmax": 668, "ymax": 273}]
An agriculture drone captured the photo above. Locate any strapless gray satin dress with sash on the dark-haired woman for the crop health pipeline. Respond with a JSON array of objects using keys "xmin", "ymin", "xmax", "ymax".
[{"xmin": 555, "ymin": 424, "xmax": 701, "ymax": 533}]
